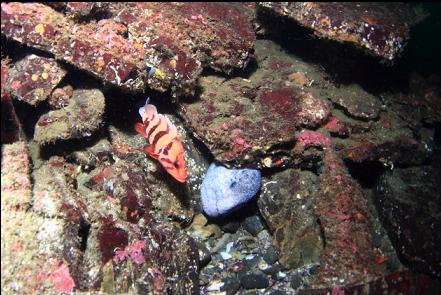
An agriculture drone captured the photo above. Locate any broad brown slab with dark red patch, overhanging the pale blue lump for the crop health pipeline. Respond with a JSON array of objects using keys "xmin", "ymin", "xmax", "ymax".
[{"xmin": 181, "ymin": 42, "xmax": 330, "ymax": 167}]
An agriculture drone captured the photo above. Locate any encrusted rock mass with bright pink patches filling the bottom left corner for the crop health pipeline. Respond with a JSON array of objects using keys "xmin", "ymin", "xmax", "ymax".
[{"xmin": 1, "ymin": 138, "xmax": 199, "ymax": 294}]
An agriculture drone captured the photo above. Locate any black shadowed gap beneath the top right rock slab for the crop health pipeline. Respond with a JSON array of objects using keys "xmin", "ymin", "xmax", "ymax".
[{"xmin": 258, "ymin": 3, "xmax": 441, "ymax": 95}]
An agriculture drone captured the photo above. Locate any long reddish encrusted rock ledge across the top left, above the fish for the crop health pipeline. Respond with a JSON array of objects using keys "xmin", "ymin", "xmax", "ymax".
[{"xmin": 1, "ymin": 3, "xmax": 254, "ymax": 94}]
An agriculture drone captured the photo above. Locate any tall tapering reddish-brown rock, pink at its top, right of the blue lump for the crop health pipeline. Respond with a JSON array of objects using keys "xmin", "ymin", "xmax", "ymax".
[{"xmin": 311, "ymin": 150, "xmax": 384, "ymax": 288}]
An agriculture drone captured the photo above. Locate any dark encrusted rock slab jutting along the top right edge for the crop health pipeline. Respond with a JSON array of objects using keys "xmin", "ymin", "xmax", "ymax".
[{"xmin": 260, "ymin": 2, "xmax": 424, "ymax": 60}]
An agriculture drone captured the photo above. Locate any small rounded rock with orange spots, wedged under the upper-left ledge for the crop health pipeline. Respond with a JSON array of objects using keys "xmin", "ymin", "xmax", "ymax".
[{"xmin": 7, "ymin": 54, "xmax": 66, "ymax": 105}]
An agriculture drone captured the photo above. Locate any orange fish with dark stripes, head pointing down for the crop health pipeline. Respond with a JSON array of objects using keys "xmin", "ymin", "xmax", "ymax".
[{"xmin": 135, "ymin": 98, "xmax": 188, "ymax": 183}]
